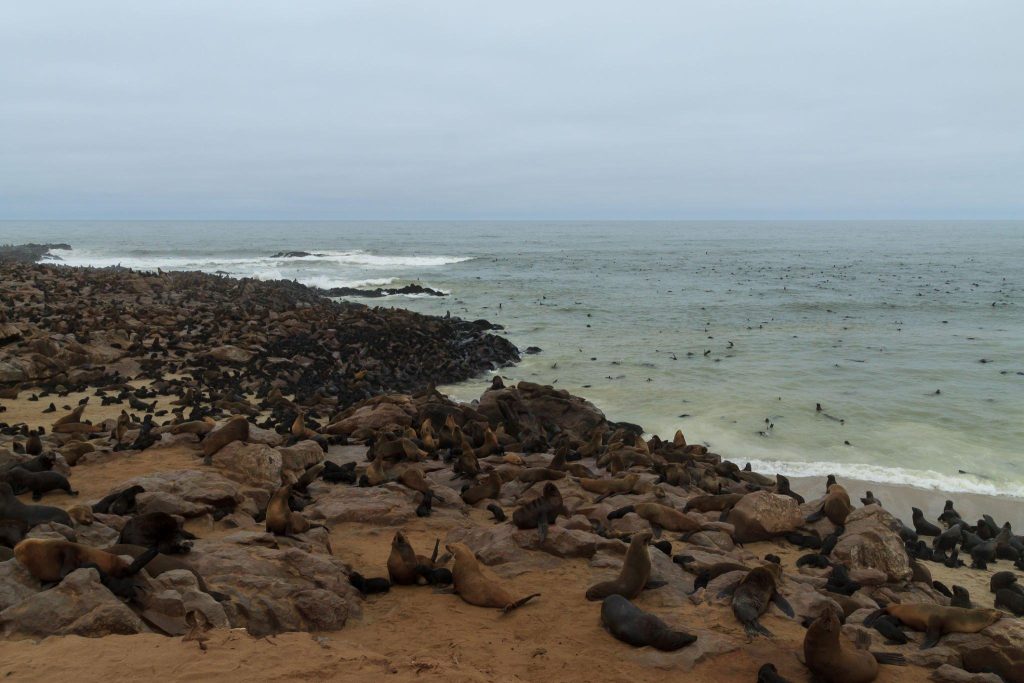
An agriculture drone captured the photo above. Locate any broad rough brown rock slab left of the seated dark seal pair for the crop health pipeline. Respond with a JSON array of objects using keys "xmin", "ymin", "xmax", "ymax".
[{"xmin": 189, "ymin": 541, "xmax": 361, "ymax": 636}]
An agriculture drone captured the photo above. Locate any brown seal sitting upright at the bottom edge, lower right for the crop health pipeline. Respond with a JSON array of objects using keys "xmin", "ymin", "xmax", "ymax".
[{"xmin": 804, "ymin": 608, "xmax": 903, "ymax": 683}]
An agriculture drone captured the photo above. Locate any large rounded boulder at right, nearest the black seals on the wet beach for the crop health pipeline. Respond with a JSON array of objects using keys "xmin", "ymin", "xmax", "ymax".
[{"xmin": 833, "ymin": 505, "xmax": 913, "ymax": 582}]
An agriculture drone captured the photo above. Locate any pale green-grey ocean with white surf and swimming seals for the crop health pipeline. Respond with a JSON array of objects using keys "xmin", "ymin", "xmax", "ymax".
[{"xmin": 0, "ymin": 221, "xmax": 1024, "ymax": 498}]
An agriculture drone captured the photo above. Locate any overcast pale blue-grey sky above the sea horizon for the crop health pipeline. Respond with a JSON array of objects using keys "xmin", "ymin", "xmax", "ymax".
[{"xmin": 0, "ymin": 0, "xmax": 1024, "ymax": 220}]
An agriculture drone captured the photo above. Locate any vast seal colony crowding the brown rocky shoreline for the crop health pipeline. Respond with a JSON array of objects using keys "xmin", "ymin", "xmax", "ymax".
[{"xmin": 0, "ymin": 259, "xmax": 1024, "ymax": 682}]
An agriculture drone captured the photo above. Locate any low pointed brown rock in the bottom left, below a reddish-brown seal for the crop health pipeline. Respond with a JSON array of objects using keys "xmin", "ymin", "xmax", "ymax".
[{"xmin": 0, "ymin": 569, "xmax": 146, "ymax": 639}]
